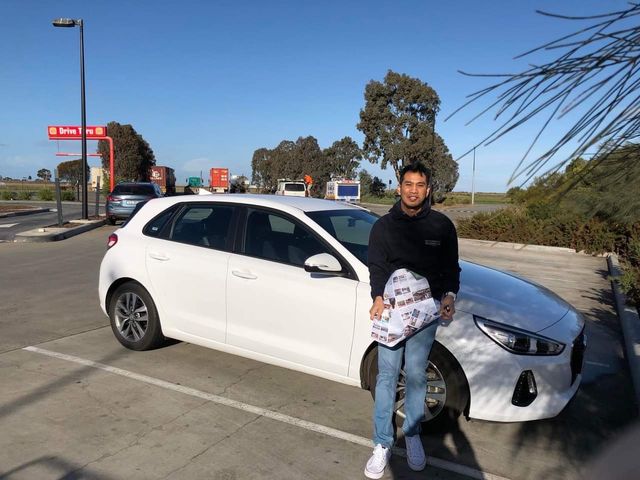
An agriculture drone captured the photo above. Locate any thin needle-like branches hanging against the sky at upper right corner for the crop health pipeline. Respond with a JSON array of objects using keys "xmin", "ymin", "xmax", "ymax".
[{"xmin": 448, "ymin": 3, "xmax": 640, "ymax": 183}]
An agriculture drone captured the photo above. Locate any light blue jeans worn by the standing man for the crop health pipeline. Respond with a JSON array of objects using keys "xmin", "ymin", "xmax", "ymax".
[{"xmin": 373, "ymin": 321, "xmax": 438, "ymax": 448}]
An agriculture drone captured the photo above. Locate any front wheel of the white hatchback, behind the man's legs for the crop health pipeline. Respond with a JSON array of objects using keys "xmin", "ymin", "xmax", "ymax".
[{"xmin": 364, "ymin": 342, "xmax": 469, "ymax": 432}]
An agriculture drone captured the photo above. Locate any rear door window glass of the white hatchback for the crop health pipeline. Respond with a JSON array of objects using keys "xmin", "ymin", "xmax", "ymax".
[{"xmin": 170, "ymin": 205, "xmax": 233, "ymax": 250}]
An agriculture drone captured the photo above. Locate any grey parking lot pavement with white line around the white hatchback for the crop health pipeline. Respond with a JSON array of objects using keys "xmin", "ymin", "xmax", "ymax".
[{"xmin": 0, "ymin": 227, "xmax": 635, "ymax": 480}]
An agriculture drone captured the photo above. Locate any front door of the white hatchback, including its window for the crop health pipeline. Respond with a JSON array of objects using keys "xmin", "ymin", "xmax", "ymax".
[{"xmin": 227, "ymin": 208, "xmax": 358, "ymax": 376}]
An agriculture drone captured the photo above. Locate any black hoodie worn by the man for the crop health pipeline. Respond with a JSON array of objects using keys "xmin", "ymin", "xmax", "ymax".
[{"xmin": 368, "ymin": 202, "xmax": 460, "ymax": 300}]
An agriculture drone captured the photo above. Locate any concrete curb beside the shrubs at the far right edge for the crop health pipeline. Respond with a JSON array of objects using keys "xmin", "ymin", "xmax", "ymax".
[{"xmin": 607, "ymin": 253, "xmax": 640, "ymax": 409}]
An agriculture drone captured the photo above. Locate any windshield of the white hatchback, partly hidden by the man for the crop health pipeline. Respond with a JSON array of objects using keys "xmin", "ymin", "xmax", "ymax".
[{"xmin": 307, "ymin": 208, "xmax": 378, "ymax": 265}]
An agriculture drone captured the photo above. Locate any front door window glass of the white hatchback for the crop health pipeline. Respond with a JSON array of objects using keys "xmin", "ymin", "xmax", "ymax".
[{"xmin": 244, "ymin": 210, "xmax": 327, "ymax": 267}]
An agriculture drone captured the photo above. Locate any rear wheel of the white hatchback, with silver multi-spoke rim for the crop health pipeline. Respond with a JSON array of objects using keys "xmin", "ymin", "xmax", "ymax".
[{"xmin": 109, "ymin": 282, "xmax": 165, "ymax": 350}]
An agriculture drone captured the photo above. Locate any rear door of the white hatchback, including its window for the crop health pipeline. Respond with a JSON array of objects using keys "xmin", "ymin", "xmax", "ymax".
[{"xmin": 146, "ymin": 202, "xmax": 235, "ymax": 342}]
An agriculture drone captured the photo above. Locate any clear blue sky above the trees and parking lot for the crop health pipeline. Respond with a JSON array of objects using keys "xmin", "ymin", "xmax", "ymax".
[{"xmin": 0, "ymin": 0, "xmax": 626, "ymax": 191}]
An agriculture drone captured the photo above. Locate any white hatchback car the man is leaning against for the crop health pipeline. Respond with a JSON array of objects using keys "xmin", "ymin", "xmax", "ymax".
[{"xmin": 99, "ymin": 195, "xmax": 586, "ymax": 428}]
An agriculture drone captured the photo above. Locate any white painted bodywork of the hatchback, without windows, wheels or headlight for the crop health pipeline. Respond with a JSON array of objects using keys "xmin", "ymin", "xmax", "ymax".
[{"xmin": 99, "ymin": 195, "xmax": 584, "ymax": 422}]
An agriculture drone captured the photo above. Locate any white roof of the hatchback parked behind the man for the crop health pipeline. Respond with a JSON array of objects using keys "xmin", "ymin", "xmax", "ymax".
[{"xmin": 146, "ymin": 193, "xmax": 362, "ymax": 212}]
